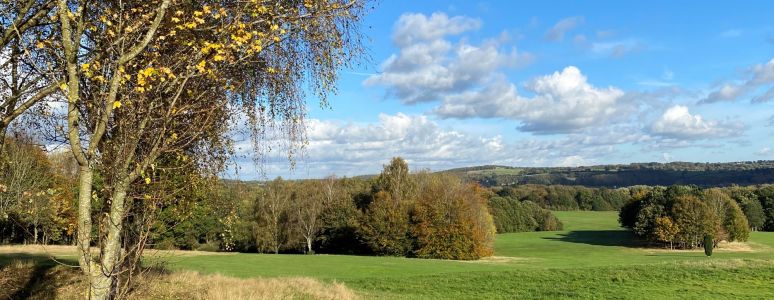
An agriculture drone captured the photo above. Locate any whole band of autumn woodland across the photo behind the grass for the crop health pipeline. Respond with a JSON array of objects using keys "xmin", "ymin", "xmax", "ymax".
[{"xmin": 6, "ymin": 135, "xmax": 774, "ymax": 259}]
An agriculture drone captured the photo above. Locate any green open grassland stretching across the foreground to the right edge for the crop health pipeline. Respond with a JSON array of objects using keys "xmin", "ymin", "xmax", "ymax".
[{"xmin": 0, "ymin": 212, "xmax": 774, "ymax": 299}]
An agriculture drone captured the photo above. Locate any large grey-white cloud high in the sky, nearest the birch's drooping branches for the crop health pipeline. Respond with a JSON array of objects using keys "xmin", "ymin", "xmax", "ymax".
[{"xmin": 364, "ymin": 13, "xmax": 533, "ymax": 104}]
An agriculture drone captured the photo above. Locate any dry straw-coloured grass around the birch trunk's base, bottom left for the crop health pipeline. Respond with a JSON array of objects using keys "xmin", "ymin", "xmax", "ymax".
[{"xmin": 0, "ymin": 261, "xmax": 357, "ymax": 300}]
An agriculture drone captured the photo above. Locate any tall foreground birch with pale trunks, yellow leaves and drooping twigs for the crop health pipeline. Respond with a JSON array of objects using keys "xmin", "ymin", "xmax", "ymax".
[{"xmin": 54, "ymin": 0, "xmax": 370, "ymax": 299}]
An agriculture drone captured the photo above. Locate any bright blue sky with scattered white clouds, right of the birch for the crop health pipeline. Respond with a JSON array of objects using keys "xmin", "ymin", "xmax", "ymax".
[{"xmin": 226, "ymin": 0, "xmax": 774, "ymax": 179}]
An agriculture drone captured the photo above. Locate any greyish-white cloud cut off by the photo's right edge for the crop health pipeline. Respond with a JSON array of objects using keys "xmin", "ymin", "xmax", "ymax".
[{"xmin": 699, "ymin": 58, "xmax": 774, "ymax": 104}]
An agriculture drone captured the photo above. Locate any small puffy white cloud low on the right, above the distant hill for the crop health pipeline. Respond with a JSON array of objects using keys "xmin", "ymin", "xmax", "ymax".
[{"xmin": 650, "ymin": 105, "xmax": 742, "ymax": 140}]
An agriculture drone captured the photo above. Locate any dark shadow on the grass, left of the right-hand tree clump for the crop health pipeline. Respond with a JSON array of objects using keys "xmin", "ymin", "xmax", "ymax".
[{"xmin": 543, "ymin": 230, "xmax": 645, "ymax": 247}]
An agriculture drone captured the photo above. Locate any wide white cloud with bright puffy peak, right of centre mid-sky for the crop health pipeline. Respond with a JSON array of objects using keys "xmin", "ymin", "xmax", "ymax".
[{"xmin": 434, "ymin": 66, "xmax": 634, "ymax": 133}]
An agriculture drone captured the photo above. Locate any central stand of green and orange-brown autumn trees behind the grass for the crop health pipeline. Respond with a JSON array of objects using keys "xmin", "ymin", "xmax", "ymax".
[{"xmin": 215, "ymin": 158, "xmax": 495, "ymax": 259}]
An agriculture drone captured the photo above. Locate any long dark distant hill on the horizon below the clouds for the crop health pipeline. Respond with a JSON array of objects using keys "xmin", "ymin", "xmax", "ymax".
[{"xmin": 443, "ymin": 160, "xmax": 774, "ymax": 187}]
